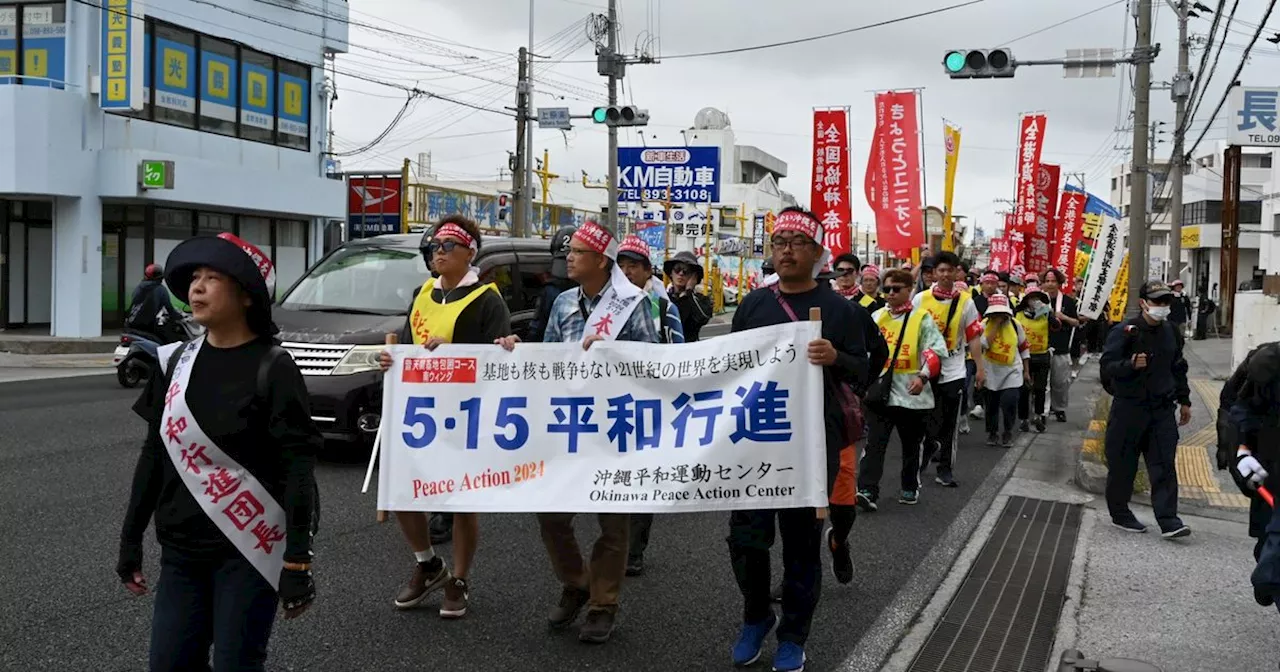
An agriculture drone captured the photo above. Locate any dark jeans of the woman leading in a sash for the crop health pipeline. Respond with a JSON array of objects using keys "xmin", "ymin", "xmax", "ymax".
[{"xmin": 151, "ymin": 548, "xmax": 278, "ymax": 672}]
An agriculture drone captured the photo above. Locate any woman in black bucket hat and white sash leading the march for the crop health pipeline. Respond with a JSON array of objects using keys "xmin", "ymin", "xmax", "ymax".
[{"xmin": 116, "ymin": 233, "xmax": 323, "ymax": 671}]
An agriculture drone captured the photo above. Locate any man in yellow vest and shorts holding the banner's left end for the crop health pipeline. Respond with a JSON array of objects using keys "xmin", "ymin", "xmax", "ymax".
[{"xmin": 379, "ymin": 215, "xmax": 511, "ymax": 618}]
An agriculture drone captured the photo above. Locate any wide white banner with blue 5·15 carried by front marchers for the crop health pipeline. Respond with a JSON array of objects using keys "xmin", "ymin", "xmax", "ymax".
[{"xmin": 378, "ymin": 321, "xmax": 827, "ymax": 513}]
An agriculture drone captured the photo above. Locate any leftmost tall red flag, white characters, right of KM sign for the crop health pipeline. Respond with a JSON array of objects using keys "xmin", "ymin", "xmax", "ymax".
[{"xmin": 809, "ymin": 110, "xmax": 854, "ymax": 259}]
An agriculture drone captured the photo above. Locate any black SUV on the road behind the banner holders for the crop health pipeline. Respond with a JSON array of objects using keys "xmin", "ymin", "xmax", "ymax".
[{"xmin": 273, "ymin": 236, "xmax": 552, "ymax": 444}]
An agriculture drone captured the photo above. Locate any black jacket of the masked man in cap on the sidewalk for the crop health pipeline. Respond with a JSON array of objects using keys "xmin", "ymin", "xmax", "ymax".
[{"xmin": 1098, "ymin": 315, "xmax": 1192, "ymax": 410}]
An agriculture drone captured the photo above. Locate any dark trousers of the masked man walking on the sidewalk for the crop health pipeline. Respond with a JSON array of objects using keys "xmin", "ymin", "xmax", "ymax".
[{"xmin": 1106, "ymin": 398, "xmax": 1183, "ymax": 531}]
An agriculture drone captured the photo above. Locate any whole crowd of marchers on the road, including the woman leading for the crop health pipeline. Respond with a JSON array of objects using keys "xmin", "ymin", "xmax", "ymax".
[{"xmin": 116, "ymin": 207, "xmax": 1132, "ymax": 672}]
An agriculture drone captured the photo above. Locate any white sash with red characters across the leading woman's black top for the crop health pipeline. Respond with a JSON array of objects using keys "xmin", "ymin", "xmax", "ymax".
[{"xmin": 159, "ymin": 337, "xmax": 287, "ymax": 589}]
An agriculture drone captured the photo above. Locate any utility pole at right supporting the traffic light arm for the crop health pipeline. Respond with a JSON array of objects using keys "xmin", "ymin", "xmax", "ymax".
[{"xmin": 1125, "ymin": 0, "xmax": 1153, "ymax": 317}]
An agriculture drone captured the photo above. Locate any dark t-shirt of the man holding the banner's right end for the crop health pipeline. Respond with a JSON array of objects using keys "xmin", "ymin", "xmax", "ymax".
[{"xmin": 732, "ymin": 283, "xmax": 883, "ymax": 452}]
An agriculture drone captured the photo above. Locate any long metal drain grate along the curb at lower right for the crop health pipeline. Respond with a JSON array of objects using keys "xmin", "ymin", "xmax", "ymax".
[{"xmin": 909, "ymin": 497, "xmax": 1082, "ymax": 672}]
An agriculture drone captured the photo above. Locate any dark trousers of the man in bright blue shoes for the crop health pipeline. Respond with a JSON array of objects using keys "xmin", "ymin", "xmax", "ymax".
[{"xmin": 727, "ymin": 508, "xmax": 823, "ymax": 646}]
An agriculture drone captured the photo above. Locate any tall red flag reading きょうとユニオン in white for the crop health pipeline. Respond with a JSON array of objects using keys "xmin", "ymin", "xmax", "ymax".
[{"xmin": 865, "ymin": 91, "xmax": 924, "ymax": 257}]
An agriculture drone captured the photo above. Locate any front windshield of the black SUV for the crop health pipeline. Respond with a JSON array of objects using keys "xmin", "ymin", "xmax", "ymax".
[{"xmin": 280, "ymin": 244, "xmax": 428, "ymax": 315}]
